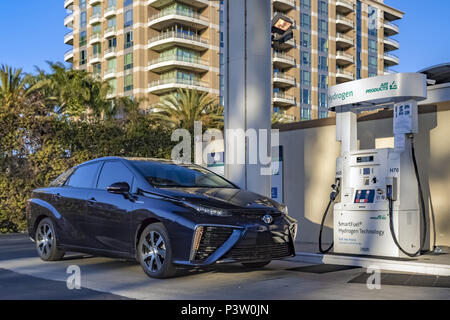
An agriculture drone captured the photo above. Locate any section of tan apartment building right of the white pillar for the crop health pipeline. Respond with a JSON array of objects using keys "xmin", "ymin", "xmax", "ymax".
[{"xmin": 272, "ymin": 0, "xmax": 403, "ymax": 120}]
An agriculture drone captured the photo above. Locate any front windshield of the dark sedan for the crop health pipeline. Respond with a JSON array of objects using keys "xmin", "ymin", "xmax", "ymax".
[{"xmin": 132, "ymin": 161, "xmax": 236, "ymax": 188}]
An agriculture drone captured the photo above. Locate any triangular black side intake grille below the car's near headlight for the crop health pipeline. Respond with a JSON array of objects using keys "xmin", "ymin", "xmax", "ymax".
[{"xmin": 194, "ymin": 227, "xmax": 233, "ymax": 261}]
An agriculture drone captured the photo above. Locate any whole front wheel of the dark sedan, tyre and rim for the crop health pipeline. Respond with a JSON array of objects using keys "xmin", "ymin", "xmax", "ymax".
[{"xmin": 137, "ymin": 223, "xmax": 175, "ymax": 279}]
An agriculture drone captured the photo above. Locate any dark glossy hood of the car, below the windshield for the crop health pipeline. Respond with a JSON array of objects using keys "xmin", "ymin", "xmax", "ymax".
[{"xmin": 153, "ymin": 188, "xmax": 282, "ymax": 211}]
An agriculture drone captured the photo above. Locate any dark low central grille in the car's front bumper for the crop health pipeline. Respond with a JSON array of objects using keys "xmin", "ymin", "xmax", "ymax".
[{"xmin": 225, "ymin": 242, "xmax": 292, "ymax": 261}]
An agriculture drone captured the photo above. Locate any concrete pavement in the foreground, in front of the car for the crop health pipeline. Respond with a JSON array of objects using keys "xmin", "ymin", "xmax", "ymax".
[{"xmin": 0, "ymin": 234, "xmax": 450, "ymax": 300}]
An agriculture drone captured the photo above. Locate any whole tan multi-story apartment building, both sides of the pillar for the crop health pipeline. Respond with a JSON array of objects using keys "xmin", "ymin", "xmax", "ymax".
[{"xmin": 64, "ymin": 0, "xmax": 403, "ymax": 121}]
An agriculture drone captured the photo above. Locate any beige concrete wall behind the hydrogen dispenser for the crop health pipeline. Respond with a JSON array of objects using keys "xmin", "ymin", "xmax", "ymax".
[{"xmin": 278, "ymin": 101, "xmax": 450, "ymax": 246}]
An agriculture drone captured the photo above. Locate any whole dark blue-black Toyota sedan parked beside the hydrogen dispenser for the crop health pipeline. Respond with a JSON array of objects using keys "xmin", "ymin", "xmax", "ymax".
[{"xmin": 26, "ymin": 157, "xmax": 297, "ymax": 278}]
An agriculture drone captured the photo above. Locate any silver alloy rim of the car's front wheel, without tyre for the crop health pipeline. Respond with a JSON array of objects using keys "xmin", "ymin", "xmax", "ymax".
[{"xmin": 141, "ymin": 231, "xmax": 166, "ymax": 272}]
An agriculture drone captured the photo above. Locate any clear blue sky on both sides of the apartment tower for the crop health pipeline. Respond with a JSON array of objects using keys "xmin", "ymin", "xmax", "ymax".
[{"xmin": 0, "ymin": 0, "xmax": 450, "ymax": 72}]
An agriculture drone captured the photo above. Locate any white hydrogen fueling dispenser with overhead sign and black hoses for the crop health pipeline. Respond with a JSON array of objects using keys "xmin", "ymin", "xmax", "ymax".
[{"xmin": 319, "ymin": 73, "xmax": 427, "ymax": 257}]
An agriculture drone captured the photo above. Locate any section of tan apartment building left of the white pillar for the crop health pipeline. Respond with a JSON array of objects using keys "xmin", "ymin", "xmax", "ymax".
[{"xmin": 64, "ymin": 0, "xmax": 220, "ymax": 107}]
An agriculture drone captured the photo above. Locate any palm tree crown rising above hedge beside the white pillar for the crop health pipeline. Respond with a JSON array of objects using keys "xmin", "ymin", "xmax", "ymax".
[{"xmin": 152, "ymin": 89, "xmax": 223, "ymax": 132}]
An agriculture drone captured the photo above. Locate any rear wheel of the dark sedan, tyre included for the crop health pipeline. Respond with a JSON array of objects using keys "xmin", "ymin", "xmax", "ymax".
[{"xmin": 35, "ymin": 218, "xmax": 65, "ymax": 261}]
